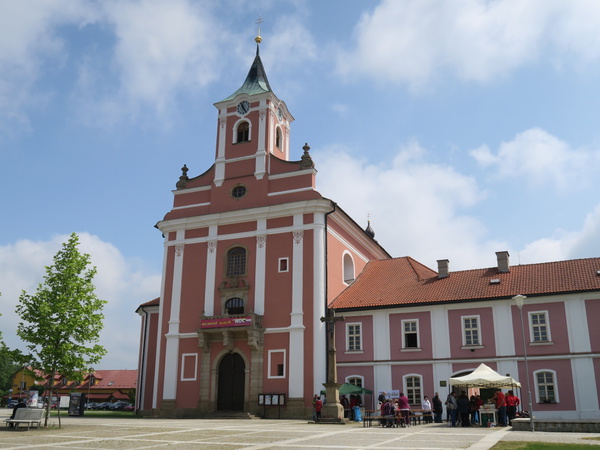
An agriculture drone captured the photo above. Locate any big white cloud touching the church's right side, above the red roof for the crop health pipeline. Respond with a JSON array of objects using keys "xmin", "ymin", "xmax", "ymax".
[{"xmin": 315, "ymin": 142, "xmax": 506, "ymax": 269}]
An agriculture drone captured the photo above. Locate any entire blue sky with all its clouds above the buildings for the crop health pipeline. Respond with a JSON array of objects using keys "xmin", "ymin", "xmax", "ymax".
[{"xmin": 0, "ymin": 0, "xmax": 600, "ymax": 369}]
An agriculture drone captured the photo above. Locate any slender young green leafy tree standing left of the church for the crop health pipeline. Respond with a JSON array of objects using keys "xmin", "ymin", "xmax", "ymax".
[{"xmin": 16, "ymin": 233, "xmax": 106, "ymax": 427}]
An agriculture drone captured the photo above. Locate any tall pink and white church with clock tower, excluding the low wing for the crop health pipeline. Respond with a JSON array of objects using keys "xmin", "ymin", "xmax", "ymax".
[{"xmin": 137, "ymin": 30, "xmax": 389, "ymax": 418}]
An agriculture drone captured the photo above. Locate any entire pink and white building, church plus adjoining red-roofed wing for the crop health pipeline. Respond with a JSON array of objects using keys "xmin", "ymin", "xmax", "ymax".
[{"xmin": 136, "ymin": 37, "xmax": 600, "ymax": 419}]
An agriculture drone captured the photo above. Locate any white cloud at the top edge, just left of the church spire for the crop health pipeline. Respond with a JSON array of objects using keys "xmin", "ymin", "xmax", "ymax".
[{"xmin": 77, "ymin": 0, "xmax": 227, "ymax": 124}]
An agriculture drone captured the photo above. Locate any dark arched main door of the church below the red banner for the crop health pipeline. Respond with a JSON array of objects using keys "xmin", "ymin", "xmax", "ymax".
[{"xmin": 217, "ymin": 353, "xmax": 246, "ymax": 411}]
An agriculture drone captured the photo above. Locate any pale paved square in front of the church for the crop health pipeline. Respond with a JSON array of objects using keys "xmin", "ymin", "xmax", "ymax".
[{"xmin": 0, "ymin": 409, "xmax": 600, "ymax": 450}]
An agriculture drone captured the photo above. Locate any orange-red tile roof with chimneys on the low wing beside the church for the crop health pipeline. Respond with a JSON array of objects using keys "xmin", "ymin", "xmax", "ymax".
[{"xmin": 330, "ymin": 257, "xmax": 600, "ymax": 309}]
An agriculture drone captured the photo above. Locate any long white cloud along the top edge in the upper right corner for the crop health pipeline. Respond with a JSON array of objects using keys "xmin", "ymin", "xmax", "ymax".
[{"xmin": 337, "ymin": 0, "xmax": 600, "ymax": 90}]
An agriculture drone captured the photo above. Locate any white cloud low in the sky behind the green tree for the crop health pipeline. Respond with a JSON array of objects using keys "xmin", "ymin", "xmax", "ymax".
[{"xmin": 0, "ymin": 233, "xmax": 160, "ymax": 369}]
